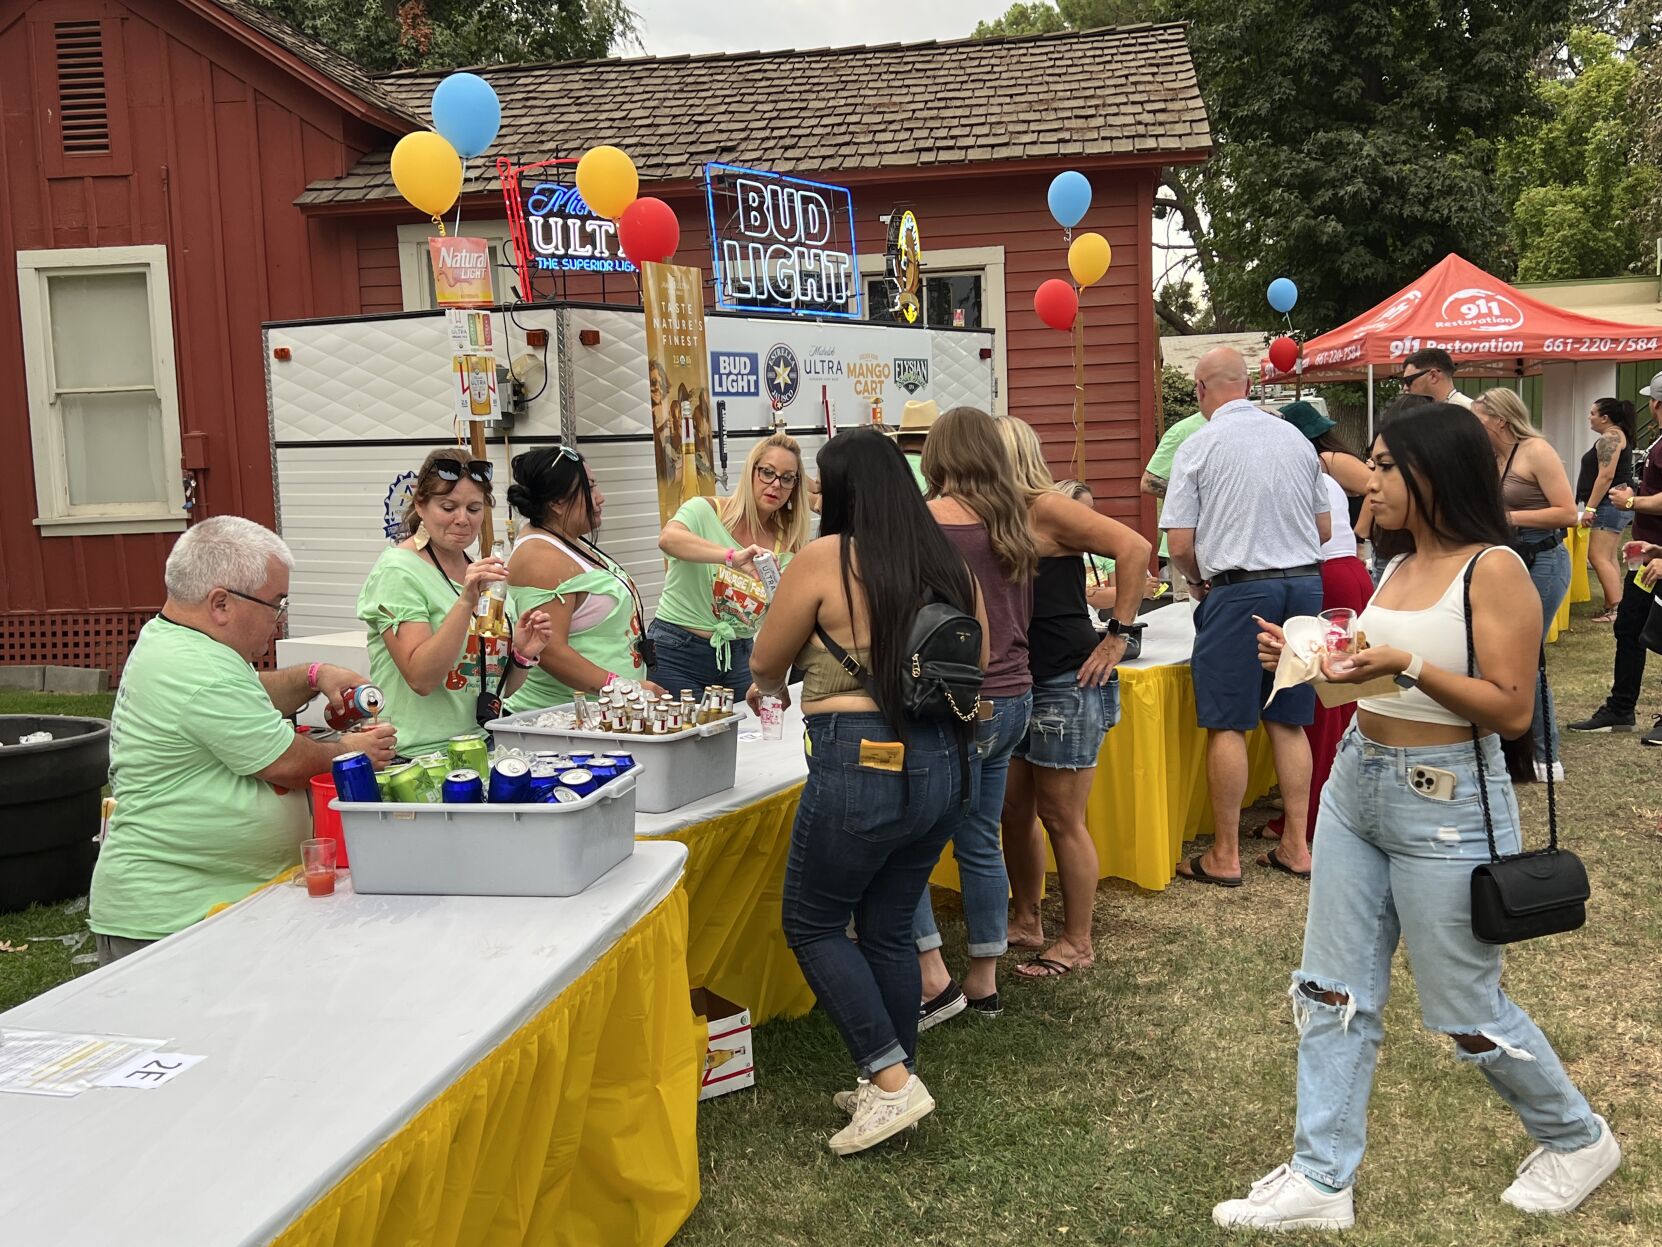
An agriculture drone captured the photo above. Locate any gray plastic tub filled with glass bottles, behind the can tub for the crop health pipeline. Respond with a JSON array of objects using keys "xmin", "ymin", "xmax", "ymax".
[{"xmin": 485, "ymin": 705, "xmax": 745, "ymax": 821}]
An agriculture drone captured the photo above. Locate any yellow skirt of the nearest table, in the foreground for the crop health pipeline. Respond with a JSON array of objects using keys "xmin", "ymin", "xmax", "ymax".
[{"xmin": 271, "ymin": 886, "xmax": 705, "ymax": 1247}]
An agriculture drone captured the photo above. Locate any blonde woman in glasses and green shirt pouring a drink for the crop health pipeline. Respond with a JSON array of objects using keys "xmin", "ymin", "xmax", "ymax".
[{"xmin": 647, "ymin": 432, "xmax": 809, "ymax": 697}]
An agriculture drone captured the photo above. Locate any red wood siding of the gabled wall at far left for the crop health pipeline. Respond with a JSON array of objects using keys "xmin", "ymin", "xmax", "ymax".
[{"xmin": 0, "ymin": 0, "xmax": 396, "ymax": 648}]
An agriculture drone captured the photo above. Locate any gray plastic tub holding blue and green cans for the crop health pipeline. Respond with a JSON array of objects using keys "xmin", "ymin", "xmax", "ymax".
[{"xmin": 329, "ymin": 771, "xmax": 635, "ymax": 896}]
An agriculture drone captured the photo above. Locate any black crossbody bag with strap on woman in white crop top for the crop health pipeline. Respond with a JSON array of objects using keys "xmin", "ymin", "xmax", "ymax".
[{"xmin": 1464, "ymin": 559, "xmax": 1592, "ymax": 944}]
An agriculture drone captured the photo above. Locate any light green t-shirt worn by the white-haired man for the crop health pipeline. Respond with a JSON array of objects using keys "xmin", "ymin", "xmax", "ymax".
[{"xmin": 88, "ymin": 619, "xmax": 309, "ymax": 939}]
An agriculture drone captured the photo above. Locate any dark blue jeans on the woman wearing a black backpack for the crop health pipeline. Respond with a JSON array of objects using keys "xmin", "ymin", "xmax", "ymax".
[{"xmin": 783, "ymin": 713, "xmax": 979, "ymax": 1077}]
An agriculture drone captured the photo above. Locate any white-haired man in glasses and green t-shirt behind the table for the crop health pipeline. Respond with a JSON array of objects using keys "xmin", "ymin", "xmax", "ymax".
[{"xmin": 88, "ymin": 515, "xmax": 397, "ymax": 964}]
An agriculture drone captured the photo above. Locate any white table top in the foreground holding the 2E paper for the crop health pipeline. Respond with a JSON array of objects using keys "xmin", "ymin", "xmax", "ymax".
[{"xmin": 0, "ymin": 843, "xmax": 686, "ymax": 1247}]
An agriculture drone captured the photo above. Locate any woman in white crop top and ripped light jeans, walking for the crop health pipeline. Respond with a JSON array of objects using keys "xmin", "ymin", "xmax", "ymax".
[{"xmin": 1212, "ymin": 402, "xmax": 1622, "ymax": 1230}]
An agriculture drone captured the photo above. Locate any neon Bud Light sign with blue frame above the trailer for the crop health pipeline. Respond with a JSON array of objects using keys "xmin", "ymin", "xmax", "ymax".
[{"xmin": 705, "ymin": 163, "xmax": 863, "ymax": 319}]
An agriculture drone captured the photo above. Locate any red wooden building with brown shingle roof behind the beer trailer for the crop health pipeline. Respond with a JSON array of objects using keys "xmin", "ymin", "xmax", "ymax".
[{"xmin": 0, "ymin": 0, "xmax": 1210, "ymax": 670}]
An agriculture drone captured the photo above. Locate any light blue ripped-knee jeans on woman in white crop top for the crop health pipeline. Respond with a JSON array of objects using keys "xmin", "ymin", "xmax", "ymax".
[{"xmin": 1290, "ymin": 727, "xmax": 1599, "ymax": 1187}]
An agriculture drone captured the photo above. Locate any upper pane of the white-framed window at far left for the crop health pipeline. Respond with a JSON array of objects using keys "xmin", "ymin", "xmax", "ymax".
[{"xmin": 47, "ymin": 273, "xmax": 155, "ymax": 389}]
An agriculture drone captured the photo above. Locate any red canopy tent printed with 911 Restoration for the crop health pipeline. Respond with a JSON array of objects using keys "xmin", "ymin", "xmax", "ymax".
[{"xmin": 1263, "ymin": 254, "xmax": 1662, "ymax": 429}]
